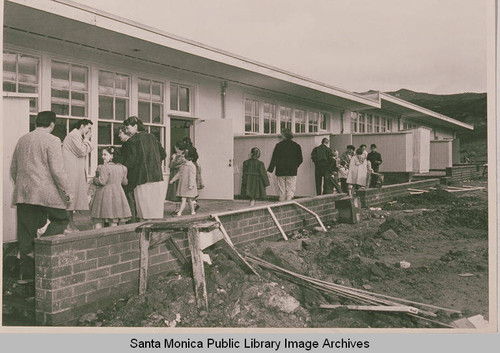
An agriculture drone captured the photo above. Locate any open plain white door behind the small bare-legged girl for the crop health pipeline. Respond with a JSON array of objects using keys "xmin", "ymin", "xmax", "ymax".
[{"xmin": 194, "ymin": 119, "xmax": 234, "ymax": 200}]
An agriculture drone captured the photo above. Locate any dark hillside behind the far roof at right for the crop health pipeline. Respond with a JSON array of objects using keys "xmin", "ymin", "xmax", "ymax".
[{"xmin": 387, "ymin": 89, "xmax": 487, "ymax": 162}]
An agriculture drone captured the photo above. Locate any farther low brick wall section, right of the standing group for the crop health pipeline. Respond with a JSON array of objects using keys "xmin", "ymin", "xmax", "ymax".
[{"xmin": 356, "ymin": 179, "xmax": 440, "ymax": 207}]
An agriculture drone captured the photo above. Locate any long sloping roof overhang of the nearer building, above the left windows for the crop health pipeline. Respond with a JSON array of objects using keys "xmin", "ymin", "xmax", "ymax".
[{"xmin": 4, "ymin": 0, "xmax": 380, "ymax": 110}]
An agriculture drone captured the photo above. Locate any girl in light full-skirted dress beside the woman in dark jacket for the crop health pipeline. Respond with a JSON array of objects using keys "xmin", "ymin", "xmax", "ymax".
[{"xmin": 90, "ymin": 147, "xmax": 132, "ymax": 229}]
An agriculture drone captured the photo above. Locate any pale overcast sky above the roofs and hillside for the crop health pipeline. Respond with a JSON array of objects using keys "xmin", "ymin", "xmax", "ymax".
[{"xmin": 72, "ymin": 0, "xmax": 488, "ymax": 94}]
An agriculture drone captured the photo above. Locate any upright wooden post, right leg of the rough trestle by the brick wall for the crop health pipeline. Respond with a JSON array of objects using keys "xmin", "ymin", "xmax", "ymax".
[{"xmin": 188, "ymin": 228, "xmax": 208, "ymax": 310}]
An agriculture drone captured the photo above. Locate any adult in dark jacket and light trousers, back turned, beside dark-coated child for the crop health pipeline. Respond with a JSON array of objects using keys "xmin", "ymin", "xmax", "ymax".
[{"xmin": 267, "ymin": 129, "xmax": 302, "ymax": 201}]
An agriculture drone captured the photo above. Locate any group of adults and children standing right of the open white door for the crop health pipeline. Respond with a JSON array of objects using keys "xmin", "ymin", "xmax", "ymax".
[{"xmin": 241, "ymin": 129, "xmax": 382, "ymax": 205}]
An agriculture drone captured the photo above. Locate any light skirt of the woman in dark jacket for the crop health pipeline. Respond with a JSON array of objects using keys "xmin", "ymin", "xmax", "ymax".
[{"xmin": 134, "ymin": 181, "xmax": 165, "ymax": 219}]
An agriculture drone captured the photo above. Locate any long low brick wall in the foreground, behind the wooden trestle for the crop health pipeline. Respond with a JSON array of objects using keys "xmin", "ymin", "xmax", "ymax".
[{"xmin": 35, "ymin": 194, "xmax": 344, "ymax": 326}]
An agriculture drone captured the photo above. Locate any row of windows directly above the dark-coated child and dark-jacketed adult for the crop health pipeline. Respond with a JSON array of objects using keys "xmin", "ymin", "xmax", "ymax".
[{"xmin": 245, "ymin": 98, "xmax": 328, "ymax": 134}]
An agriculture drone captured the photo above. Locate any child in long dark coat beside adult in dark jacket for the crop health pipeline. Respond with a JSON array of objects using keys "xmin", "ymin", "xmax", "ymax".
[{"xmin": 241, "ymin": 147, "xmax": 269, "ymax": 206}]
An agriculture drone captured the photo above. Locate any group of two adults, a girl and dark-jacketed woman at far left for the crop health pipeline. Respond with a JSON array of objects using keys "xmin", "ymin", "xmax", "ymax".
[{"xmin": 10, "ymin": 111, "xmax": 166, "ymax": 279}]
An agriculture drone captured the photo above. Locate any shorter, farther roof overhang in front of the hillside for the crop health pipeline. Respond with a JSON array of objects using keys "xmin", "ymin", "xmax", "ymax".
[{"xmin": 360, "ymin": 92, "xmax": 474, "ymax": 130}]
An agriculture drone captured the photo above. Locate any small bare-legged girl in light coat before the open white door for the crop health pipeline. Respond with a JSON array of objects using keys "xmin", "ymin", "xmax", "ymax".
[{"xmin": 170, "ymin": 150, "xmax": 198, "ymax": 217}]
